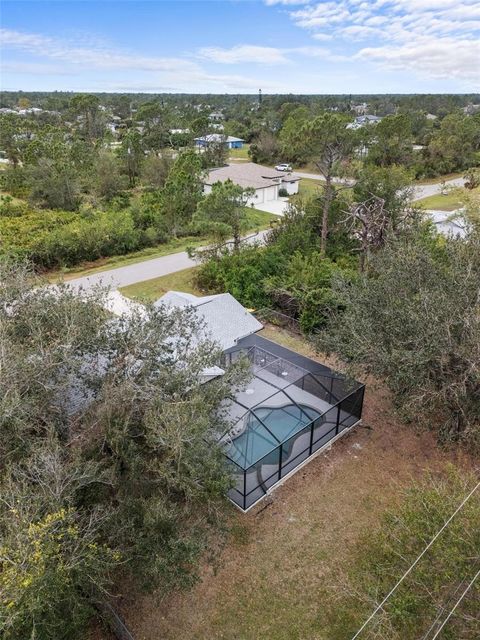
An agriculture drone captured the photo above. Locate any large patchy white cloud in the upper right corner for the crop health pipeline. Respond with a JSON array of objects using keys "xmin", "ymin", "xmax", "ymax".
[{"xmin": 278, "ymin": 0, "xmax": 480, "ymax": 89}]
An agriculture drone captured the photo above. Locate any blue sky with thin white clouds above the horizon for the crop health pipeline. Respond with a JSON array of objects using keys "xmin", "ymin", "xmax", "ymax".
[{"xmin": 0, "ymin": 0, "xmax": 480, "ymax": 94}]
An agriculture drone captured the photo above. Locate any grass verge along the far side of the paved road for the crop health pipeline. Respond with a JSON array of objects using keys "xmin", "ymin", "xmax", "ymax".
[{"xmin": 46, "ymin": 208, "xmax": 276, "ymax": 282}]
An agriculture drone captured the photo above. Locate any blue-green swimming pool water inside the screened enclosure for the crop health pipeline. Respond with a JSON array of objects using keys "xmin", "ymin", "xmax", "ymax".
[{"xmin": 226, "ymin": 405, "xmax": 320, "ymax": 469}]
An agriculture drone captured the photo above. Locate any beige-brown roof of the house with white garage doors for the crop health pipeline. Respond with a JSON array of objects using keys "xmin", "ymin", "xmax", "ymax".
[{"xmin": 204, "ymin": 162, "xmax": 300, "ymax": 189}]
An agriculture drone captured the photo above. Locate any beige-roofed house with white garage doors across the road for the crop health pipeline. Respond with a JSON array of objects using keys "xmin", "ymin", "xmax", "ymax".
[{"xmin": 204, "ymin": 162, "xmax": 300, "ymax": 205}]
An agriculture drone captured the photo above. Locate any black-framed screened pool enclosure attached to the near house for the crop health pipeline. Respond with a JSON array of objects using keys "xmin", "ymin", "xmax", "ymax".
[{"xmin": 221, "ymin": 335, "xmax": 365, "ymax": 510}]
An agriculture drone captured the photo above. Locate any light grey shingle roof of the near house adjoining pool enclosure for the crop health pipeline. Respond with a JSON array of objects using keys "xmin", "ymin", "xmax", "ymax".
[{"xmin": 154, "ymin": 291, "xmax": 263, "ymax": 349}]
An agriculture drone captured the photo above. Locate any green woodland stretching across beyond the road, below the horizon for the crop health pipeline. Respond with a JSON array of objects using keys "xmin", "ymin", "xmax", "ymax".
[{"xmin": 0, "ymin": 94, "xmax": 480, "ymax": 268}]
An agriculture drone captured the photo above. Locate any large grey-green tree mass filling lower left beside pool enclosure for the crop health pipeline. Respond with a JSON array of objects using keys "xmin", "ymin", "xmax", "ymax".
[{"xmin": 0, "ymin": 261, "xmax": 248, "ymax": 640}]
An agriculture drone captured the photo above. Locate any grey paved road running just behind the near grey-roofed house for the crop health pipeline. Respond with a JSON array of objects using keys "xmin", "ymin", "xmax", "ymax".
[{"xmin": 67, "ymin": 230, "xmax": 268, "ymax": 289}]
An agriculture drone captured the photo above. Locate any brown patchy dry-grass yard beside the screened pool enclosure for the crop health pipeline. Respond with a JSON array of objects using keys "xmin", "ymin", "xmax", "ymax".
[{"xmin": 116, "ymin": 328, "xmax": 468, "ymax": 640}]
